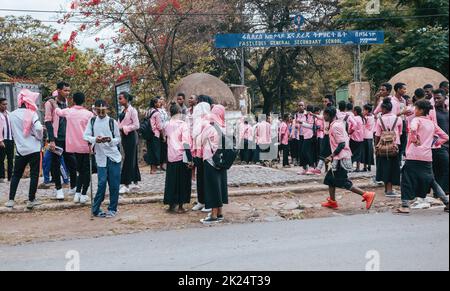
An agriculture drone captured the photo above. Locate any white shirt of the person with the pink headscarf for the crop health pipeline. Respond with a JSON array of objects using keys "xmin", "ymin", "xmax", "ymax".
[{"xmin": 9, "ymin": 108, "xmax": 44, "ymax": 156}]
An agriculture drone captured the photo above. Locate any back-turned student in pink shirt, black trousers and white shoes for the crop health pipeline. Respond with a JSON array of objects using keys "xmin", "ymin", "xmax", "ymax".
[{"xmin": 53, "ymin": 92, "xmax": 94, "ymax": 204}]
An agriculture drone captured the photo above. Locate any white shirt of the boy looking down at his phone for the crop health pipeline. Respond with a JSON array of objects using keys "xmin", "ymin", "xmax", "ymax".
[{"xmin": 84, "ymin": 116, "xmax": 122, "ymax": 168}]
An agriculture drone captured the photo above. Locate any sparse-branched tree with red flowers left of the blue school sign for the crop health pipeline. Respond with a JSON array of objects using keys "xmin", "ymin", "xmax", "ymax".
[{"xmin": 60, "ymin": 0, "xmax": 234, "ymax": 97}]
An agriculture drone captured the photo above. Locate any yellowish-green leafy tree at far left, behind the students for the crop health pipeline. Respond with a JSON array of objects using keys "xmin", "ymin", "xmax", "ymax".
[{"xmin": 0, "ymin": 16, "xmax": 117, "ymax": 103}]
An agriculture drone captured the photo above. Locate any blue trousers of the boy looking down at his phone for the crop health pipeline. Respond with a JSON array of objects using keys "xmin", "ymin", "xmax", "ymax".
[{"xmin": 92, "ymin": 158, "xmax": 121, "ymax": 215}]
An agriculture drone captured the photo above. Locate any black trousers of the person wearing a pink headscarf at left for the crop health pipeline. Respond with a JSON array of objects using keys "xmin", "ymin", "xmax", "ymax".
[{"xmin": 9, "ymin": 153, "xmax": 41, "ymax": 201}]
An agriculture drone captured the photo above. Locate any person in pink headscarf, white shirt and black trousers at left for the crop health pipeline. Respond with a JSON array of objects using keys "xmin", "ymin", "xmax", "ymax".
[{"xmin": 6, "ymin": 89, "xmax": 44, "ymax": 210}]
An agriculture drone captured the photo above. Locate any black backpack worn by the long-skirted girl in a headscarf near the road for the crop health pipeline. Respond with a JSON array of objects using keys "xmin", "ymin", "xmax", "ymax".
[{"xmin": 212, "ymin": 124, "xmax": 239, "ymax": 170}]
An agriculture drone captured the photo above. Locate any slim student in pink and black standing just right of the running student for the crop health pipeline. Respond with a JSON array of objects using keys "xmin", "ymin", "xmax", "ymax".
[{"xmin": 350, "ymin": 106, "xmax": 367, "ymax": 172}]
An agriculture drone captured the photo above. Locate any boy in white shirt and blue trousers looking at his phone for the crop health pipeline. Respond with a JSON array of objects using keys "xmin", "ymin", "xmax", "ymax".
[{"xmin": 84, "ymin": 100, "xmax": 122, "ymax": 218}]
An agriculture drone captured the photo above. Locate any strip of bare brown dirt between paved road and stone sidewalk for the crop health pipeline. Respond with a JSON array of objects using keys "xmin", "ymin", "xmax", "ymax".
[{"xmin": 0, "ymin": 188, "xmax": 428, "ymax": 245}]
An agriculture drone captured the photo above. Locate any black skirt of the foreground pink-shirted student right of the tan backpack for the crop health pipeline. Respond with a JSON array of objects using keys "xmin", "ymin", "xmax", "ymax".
[{"xmin": 401, "ymin": 160, "xmax": 434, "ymax": 200}]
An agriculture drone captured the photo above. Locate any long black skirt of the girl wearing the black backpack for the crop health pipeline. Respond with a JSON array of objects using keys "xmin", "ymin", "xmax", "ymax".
[{"xmin": 204, "ymin": 161, "xmax": 228, "ymax": 209}]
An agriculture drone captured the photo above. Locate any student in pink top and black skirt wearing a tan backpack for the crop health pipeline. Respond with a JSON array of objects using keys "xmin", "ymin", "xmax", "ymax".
[{"xmin": 375, "ymin": 98, "xmax": 403, "ymax": 197}]
